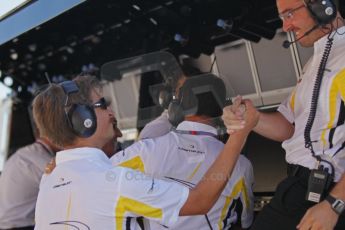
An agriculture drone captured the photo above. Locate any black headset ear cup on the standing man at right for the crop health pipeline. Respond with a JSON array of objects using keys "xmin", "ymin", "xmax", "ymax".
[{"xmin": 304, "ymin": 0, "xmax": 337, "ymax": 25}]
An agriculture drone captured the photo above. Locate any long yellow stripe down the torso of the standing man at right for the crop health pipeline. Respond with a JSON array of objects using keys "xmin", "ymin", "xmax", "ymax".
[{"xmin": 321, "ymin": 69, "xmax": 345, "ymax": 146}]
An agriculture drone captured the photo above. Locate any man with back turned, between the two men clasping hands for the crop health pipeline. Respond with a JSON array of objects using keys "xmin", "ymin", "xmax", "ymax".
[{"xmin": 111, "ymin": 74, "xmax": 254, "ymax": 230}]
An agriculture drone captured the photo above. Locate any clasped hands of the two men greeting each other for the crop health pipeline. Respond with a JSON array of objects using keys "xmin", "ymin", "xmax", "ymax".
[{"xmin": 222, "ymin": 96, "xmax": 259, "ymax": 134}]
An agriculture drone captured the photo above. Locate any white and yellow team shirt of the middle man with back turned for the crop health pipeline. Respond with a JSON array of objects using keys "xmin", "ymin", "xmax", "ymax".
[{"xmin": 111, "ymin": 121, "xmax": 254, "ymax": 229}]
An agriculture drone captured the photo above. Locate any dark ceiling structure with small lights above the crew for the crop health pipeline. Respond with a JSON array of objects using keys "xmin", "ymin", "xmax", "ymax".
[{"xmin": 0, "ymin": 0, "xmax": 342, "ymax": 97}]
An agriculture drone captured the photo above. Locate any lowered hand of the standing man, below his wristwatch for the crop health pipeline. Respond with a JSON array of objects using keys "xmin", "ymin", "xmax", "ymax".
[{"xmin": 297, "ymin": 201, "xmax": 339, "ymax": 230}]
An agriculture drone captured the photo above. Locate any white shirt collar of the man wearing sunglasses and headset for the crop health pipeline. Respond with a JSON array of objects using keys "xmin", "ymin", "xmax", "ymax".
[{"xmin": 56, "ymin": 147, "xmax": 110, "ymax": 165}]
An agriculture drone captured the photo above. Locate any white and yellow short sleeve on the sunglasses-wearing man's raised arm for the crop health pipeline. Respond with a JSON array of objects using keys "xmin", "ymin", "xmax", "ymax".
[{"xmin": 116, "ymin": 168, "xmax": 189, "ymax": 226}]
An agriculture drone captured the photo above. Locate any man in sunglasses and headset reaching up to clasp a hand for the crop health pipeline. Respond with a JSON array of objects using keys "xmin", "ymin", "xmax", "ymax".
[{"xmin": 33, "ymin": 76, "xmax": 253, "ymax": 230}]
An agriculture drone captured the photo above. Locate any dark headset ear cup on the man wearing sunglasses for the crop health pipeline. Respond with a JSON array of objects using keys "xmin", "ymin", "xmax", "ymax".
[{"xmin": 68, "ymin": 104, "xmax": 97, "ymax": 138}]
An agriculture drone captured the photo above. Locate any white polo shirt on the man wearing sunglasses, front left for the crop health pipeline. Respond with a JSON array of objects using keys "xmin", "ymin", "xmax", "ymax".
[{"xmin": 35, "ymin": 148, "xmax": 189, "ymax": 230}]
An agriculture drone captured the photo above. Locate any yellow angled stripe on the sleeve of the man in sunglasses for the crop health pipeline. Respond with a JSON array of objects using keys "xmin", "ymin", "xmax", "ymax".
[{"xmin": 115, "ymin": 196, "xmax": 163, "ymax": 230}]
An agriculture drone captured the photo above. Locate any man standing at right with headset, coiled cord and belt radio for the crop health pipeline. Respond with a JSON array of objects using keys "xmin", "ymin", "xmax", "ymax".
[{"xmin": 223, "ymin": 0, "xmax": 345, "ymax": 230}]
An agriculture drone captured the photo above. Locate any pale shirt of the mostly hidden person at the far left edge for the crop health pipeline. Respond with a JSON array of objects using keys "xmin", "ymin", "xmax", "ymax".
[{"xmin": 0, "ymin": 140, "xmax": 55, "ymax": 229}]
